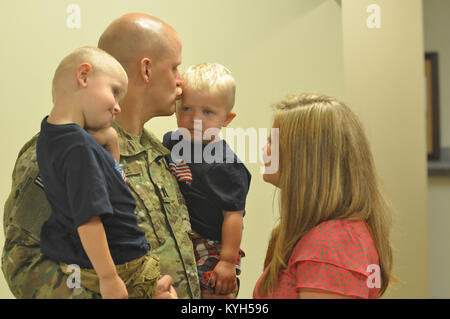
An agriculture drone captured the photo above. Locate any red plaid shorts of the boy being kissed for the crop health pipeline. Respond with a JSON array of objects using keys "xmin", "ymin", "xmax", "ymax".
[{"xmin": 193, "ymin": 234, "xmax": 245, "ymax": 289}]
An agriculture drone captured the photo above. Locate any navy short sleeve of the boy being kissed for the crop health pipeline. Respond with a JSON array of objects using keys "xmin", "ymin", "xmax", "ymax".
[{"xmin": 205, "ymin": 163, "xmax": 250, "ymax": 211}]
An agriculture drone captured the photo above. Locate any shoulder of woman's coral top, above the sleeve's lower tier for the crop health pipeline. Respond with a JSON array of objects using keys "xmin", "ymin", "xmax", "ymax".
[{"xmin": 290, "ymin": 220, "xmax": 378, "ymax": 274}]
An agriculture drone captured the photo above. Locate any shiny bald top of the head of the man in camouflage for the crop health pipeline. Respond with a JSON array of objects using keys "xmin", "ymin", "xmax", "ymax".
[{"xmin": 98, "ymin": 13, "xmax": 178, "ymax": 70}]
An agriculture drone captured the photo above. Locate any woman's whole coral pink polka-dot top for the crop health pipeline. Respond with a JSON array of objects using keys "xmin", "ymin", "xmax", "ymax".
[{"xmin": 253, "ymin": 220, "xmax": 381, "ymax": 299}]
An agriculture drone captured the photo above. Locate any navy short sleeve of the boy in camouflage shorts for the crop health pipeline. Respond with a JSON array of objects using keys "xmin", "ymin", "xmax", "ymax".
[{"xmin": 62, "ymin": 146, "xmax": 113, "ymax": 229}]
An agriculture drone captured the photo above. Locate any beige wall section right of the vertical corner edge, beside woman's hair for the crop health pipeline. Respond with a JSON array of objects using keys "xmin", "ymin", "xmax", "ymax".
[{"xmin": 342, "ymin": 0, "xmax": 429, "ymax": 298}]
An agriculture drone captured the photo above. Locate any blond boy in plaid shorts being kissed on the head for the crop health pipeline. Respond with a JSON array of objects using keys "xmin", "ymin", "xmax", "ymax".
[{"xmin": 163, "ymin": 63, "xmax": 251, "ymax": 299}]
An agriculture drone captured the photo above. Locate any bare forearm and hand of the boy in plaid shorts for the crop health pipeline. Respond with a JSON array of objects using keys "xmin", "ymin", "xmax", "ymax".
[{"xmin": 211, "ymin": 210, "xmax": 243, "ymax": 294}]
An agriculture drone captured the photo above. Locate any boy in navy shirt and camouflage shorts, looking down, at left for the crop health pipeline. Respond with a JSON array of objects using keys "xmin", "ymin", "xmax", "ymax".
[{"xmin": 36, "ymin": 47, "xmax": 160, "ymax": 298}]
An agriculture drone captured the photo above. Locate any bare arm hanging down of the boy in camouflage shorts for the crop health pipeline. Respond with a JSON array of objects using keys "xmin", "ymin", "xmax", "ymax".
[{"xmin": 78, "ymin": 216, "xmax": 128, "ymax": 299}]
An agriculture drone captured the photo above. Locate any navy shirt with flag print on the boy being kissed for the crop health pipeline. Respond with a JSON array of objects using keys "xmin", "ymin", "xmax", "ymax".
[{"xmin": 163, "ymin": 131, "xmax": 251, "ymax": 240}]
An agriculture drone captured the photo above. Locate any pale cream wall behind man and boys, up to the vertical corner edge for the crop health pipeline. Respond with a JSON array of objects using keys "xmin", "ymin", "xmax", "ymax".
[{"xmin": 0, "ymin": 0, "xmax": 343, "ymax": 298}]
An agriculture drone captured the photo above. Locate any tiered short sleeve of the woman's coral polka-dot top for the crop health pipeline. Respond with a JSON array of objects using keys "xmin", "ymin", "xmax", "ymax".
[{"xmin": 292, "ymin": 221, "xmax": 378, "ymax": 298}]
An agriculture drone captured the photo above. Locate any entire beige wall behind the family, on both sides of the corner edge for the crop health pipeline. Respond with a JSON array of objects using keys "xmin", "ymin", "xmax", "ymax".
[{"xmin": 0, "ymin": 0, "xmax": 428, "ymax": 298}]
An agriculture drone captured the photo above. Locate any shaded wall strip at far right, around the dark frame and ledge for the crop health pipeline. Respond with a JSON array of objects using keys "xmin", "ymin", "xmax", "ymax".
[{"xmin": 423, "ymin": 0, "xmax": 450, "ymax": 298}]
